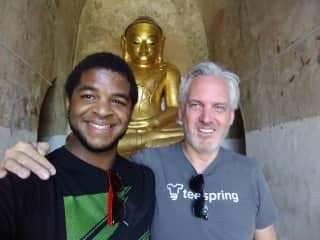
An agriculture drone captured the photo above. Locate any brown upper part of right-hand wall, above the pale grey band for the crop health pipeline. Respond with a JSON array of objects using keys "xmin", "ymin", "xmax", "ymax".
[{"xmin": 206, "ymin": 0, "xmax": 320, "ymax": 130}]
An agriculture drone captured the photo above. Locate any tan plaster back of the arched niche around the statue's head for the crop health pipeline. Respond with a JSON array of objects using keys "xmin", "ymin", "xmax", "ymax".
[{"xmin": 74, "ymin": 0, "xmax": 209, "ymax": 74}]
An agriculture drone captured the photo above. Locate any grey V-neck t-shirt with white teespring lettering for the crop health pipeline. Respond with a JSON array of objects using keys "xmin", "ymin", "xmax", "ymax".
[{"xmin": 130, "ymin": 143, "xmax": 276, "ymax": 240}]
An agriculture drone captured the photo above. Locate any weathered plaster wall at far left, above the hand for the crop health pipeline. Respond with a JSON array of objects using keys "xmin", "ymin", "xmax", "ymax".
[{"xmin": 0, "ymin": 0, "xmax": 54, "ymax": 159}]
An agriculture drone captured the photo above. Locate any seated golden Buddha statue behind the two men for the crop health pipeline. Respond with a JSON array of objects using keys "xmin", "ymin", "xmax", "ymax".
[{"xmin": 119, "ymin": 17, "xmax": 183, "ymax": 155}]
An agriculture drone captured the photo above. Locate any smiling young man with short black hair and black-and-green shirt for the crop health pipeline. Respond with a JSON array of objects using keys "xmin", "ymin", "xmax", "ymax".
[{"xmin": 0, "ymin": 53, "xmax": 154, "ymax": 240}]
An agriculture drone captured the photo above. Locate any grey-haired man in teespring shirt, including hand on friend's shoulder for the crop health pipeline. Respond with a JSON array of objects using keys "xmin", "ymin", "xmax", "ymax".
[{"xmin": 0, "ymin": 63, "xmax": 276, "ymax": 240}]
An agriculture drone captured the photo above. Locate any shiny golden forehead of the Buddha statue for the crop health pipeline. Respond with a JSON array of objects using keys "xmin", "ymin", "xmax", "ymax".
[{"xmin": 125, "ymin": 23, "xmax": 162, "ymax": 38}]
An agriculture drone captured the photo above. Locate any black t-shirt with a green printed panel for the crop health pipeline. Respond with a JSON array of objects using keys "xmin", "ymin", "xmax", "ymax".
[{"xmin": 0, "ymin": 147, "xmax": 155, "ymax": 240}]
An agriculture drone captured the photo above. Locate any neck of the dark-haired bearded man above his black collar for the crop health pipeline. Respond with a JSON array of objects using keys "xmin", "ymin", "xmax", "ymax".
[{"xmin": 66, "ymin": 137, "xmax": 117, "ymax": 170}]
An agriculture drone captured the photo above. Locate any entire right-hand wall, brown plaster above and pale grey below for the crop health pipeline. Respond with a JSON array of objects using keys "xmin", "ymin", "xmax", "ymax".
[{"xmin": 205, "ymin": 0, "xmax": 320, "ymax": 237}]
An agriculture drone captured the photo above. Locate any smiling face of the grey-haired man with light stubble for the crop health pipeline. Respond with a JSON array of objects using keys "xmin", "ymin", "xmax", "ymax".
[{"xmin": 179, "ymin": 75, "xmax": 234, "ymax": 153}]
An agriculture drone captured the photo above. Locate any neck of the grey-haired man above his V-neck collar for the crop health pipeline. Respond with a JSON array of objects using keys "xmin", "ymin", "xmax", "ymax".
[{"xmin": 182, "ymin": 140, "xmax": 219, "ymax": 174}]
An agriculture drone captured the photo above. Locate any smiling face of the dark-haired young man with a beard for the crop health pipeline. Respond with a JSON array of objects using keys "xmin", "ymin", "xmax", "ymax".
[{"xmin": 67, "ymin": 68, "xmax": 132, "ymax": 152}]
